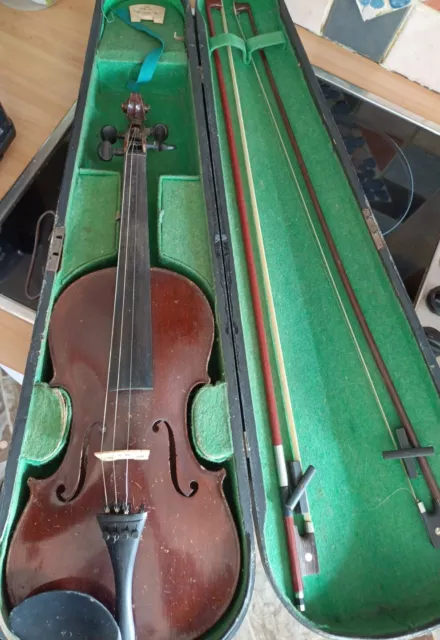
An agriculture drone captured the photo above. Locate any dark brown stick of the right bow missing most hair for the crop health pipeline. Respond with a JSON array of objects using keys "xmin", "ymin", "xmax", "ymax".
[{"xmin": 234, "ymin": 2, "xmax": 440, "ymax": 548}]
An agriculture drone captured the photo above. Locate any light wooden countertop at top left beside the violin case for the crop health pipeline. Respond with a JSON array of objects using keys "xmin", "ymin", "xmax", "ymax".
[{"xmin": 0, "ymin": 0, "xmax": 94, "ymax": 201}]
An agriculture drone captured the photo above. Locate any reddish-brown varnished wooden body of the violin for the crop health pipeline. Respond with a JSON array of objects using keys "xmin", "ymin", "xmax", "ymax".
[{"xmin": 7, "ymin": 268, "xmax": 240, "ymax": 640}]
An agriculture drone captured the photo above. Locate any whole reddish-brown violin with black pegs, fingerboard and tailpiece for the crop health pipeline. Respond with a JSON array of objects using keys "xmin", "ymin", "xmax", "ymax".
[{"xmin": 6, "ymin": 93, "xmax": 240, "ymax": 640}]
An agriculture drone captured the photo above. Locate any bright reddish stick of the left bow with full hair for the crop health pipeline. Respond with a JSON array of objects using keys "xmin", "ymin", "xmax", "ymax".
[{"xmin": 206, "ymin": 0, "xmax": 305, "ymax": 611}]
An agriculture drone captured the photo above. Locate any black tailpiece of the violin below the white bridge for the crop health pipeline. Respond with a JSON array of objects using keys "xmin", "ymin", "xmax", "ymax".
[{"xmin": 97, "ymin": 506, "xmax": 147, "ymax": 640}]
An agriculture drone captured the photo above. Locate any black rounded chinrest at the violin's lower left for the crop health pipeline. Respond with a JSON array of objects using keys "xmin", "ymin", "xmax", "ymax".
[{"xmin": 9, "ymin": 591, "xmax": 121, "ymax": 640}]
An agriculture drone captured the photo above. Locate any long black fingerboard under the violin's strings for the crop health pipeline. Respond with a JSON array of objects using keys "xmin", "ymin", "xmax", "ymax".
[{"xmin": 109, "ymin": 148, "xmax": 153, "ymax": 391}]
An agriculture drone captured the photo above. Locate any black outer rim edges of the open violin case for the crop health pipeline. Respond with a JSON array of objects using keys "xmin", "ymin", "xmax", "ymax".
[{"xmin": 0, "ymin": 0, "xmax": 440, "ymax": 639}]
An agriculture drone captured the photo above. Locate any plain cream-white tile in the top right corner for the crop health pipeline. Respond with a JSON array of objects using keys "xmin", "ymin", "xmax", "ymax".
[{"xmin": 383, "ymin": 4, "xmax": 440, "ymax": 92}]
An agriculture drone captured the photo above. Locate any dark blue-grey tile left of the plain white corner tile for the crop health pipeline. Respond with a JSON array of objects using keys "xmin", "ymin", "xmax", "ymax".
[{"xmin": 324, "ymin": 0, "xmax": 408, "ymax": 62}]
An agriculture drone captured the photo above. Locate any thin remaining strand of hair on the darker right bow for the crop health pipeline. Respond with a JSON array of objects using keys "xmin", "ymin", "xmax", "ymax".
[{"xmin": 234, "ymin": 12, "xmax": 418, "ymax": 502}]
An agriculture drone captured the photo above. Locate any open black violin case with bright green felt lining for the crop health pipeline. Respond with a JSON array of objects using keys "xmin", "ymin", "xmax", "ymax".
[{"xmin": 0, "ymin": 0, "xmax": 440, "ymax": 640}]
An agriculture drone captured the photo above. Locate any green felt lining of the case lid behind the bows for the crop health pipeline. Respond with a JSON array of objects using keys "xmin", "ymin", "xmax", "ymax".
[{"xmin": 200, "ymin": 0, "xmax": 440, "ymax": 637}]
